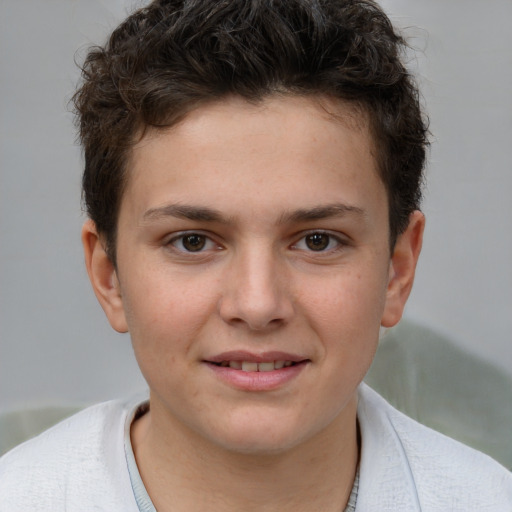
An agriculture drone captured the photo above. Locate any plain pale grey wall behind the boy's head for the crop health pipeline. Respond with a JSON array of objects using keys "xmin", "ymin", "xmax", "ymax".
[{"xmin": 0, "ymin": 0, "xmax": 512, "ymax": 409}]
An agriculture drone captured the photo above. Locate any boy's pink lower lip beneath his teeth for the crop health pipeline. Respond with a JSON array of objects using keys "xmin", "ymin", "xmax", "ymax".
[{"xmin": 206, "ymin": 361, "xmax": 308, "ymax": 391}]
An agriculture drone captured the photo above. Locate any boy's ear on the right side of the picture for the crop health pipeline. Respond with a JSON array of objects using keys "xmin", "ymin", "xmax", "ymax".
[{"xmin": 381, "ymin": 210, "xmax": 425, "ymax": 327}]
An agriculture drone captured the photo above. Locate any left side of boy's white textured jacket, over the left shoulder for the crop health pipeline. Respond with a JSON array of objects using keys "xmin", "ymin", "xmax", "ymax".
[{"xmin": 0, "ymin": 401, "xmax": 138, "ymax": 512}]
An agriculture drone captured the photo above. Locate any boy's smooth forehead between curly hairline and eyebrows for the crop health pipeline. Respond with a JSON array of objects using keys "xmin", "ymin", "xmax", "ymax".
[{"xmin": 123, "ymin": 95, "xmax": 383, "ymax": 223}]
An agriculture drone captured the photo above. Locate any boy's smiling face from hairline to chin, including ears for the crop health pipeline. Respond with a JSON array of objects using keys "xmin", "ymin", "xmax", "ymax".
[{"xmin": 84, "ymin": 97, "xmax": 421, "ymax": 453}]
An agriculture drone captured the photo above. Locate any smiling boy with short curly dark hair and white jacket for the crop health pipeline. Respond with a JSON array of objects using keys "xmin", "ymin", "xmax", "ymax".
[{"xmin": 0, "ymin": 0, "xmax": 512, "ymax": 512}]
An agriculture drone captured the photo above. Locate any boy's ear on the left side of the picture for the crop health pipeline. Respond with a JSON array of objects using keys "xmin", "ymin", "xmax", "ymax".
[{"xmin": 82, "ymin": 219, "xmax": 128, "ymax": 332}]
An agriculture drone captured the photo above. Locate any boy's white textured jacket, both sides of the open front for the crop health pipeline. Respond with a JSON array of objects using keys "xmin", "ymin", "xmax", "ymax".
[{"xmin": 0, "ymin": 384, "xmax": 512, "ymax": 512}]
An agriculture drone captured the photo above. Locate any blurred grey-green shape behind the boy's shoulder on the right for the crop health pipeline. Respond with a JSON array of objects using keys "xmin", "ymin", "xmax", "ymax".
[{"xmin": 365, "ymin": 320, "xmax": 512, "ymax": 469}]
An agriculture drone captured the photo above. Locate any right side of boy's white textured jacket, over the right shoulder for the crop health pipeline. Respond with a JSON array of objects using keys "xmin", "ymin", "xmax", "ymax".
[{"xmin": 356, "ymin": 384, "xmax": 512, "ymax": 512}]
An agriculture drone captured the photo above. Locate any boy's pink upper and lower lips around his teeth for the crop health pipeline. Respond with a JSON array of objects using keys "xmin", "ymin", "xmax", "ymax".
[{"xmin": 203, "ymin": 350, "xmax": 311, "ymax": 392}]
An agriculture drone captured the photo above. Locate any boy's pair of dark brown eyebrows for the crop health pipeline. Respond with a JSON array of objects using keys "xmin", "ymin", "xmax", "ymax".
[{"xmin": 142, "ymin": 203, "xmax": 365, "ymax": 224}]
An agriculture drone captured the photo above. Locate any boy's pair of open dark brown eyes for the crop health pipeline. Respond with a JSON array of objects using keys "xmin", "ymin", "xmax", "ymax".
[{"xmin": 165, "ymin": 230, "xmax": 348, "ymax": 255}]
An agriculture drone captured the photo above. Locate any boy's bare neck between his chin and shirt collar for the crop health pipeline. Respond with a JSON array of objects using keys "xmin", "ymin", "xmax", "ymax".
[{"xmin": 132, "ymin": 397, "xmax": 359, "ymax": 512}]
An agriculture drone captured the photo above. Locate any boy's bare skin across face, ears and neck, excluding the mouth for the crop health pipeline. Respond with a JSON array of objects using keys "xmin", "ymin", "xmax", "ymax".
[{"xmin": 82, "ymin": 96, "xmax": 424, "ymax": 512}]
